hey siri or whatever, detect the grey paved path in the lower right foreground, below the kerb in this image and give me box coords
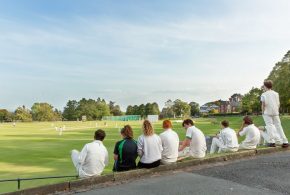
[75,152,290,195]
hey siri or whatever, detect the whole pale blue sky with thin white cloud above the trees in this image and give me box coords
[0,0,290,110]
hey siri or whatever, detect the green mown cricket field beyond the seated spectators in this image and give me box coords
[0,116,290,193]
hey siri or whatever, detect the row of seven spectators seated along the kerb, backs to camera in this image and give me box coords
[71,116,274,177]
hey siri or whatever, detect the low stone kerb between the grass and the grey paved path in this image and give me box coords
[5,148,290,195]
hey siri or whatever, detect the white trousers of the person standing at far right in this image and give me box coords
[263,115,288,143]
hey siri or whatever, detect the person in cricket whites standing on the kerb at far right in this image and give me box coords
[261,80,289,148]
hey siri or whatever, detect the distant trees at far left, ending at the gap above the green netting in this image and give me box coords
[0,98,123,122]
